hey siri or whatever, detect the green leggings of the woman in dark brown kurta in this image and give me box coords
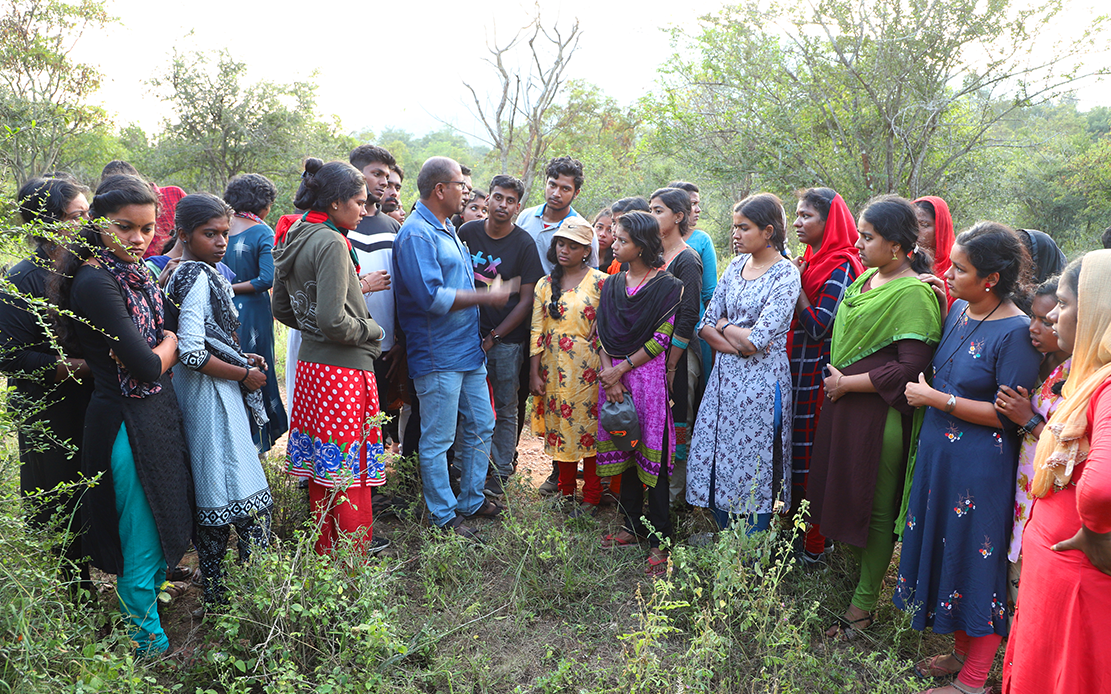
[850,408,905,612]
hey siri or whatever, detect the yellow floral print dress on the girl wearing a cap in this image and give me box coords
[529,269,608,463]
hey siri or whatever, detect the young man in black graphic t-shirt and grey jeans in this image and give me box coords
[459,175,544,494]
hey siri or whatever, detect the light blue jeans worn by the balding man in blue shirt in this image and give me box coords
[413,366,493,527]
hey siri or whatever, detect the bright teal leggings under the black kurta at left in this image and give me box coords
[112,424,170,655]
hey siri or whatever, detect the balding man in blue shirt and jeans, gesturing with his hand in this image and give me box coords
[393,157,509,539]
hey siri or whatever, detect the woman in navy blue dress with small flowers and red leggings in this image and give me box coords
[894,222,1041,694]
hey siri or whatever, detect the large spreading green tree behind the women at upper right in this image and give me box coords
[650,0,1107,204]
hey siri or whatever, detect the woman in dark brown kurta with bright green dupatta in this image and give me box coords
[808,195,941,638]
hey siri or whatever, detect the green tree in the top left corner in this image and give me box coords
[0,0,113,184]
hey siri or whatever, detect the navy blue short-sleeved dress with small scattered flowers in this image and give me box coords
[894,301,1041,636]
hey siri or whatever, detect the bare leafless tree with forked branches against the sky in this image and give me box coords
[463,4,582,197]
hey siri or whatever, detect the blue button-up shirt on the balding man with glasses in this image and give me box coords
[392,202,486,379]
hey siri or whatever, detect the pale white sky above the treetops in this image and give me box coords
[74,0,1111,143]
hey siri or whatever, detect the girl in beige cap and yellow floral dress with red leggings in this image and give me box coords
[529,217,608,517]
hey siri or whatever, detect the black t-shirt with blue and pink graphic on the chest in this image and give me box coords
[459,220,544,344]
